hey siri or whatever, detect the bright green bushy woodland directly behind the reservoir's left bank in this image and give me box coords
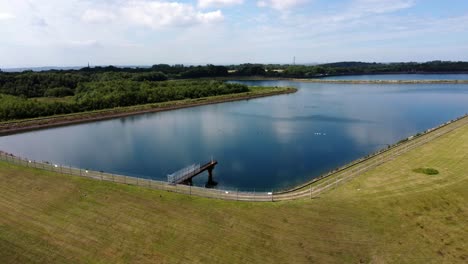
[0,80,249,121]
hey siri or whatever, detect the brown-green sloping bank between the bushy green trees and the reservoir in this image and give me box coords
[0,87,297,136]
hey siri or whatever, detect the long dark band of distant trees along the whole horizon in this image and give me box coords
[0,61,468,98]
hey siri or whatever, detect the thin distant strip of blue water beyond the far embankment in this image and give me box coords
[322,73,468,80]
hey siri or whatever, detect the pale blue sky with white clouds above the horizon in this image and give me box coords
[0,0,468,68]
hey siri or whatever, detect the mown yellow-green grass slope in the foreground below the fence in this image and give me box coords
[0,126,468,263]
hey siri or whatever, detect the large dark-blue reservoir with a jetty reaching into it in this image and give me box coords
[0,81,468,190]
